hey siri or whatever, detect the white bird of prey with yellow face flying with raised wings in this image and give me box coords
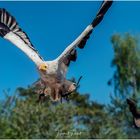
[0,1,112,101]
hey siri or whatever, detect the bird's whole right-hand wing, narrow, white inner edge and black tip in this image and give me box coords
[57,1,112,75]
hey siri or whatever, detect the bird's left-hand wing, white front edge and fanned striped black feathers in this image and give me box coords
[0,9,43,66]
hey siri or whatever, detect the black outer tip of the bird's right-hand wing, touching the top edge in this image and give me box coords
[91,0,113,27]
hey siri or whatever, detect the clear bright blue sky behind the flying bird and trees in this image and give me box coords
[0,1,140,103]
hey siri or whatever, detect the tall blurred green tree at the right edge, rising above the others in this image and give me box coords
[107,34,140,138]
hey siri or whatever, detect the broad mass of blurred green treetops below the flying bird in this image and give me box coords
[0,87,104,139]
